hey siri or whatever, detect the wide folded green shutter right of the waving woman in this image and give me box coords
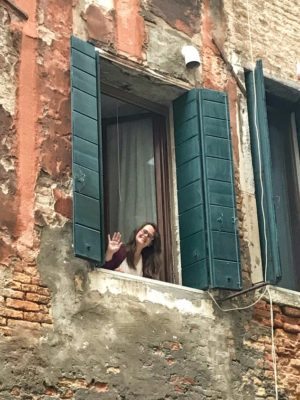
[174,89,241,290]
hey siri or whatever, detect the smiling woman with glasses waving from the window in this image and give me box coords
[103,222,161,279]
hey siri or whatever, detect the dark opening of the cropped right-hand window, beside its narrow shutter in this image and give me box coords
[267,96,300,291]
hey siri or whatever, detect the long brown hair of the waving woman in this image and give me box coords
[126,222,161,279]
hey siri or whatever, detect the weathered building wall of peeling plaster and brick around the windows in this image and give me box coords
[0,0,300,400]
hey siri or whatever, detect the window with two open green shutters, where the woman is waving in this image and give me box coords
[71,34,241,289]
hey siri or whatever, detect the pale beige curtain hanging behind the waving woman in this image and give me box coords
[107,118,156,242]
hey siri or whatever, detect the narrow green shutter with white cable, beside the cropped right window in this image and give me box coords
[245,60,281,284]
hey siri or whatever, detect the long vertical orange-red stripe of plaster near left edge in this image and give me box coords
[17,0,38,247]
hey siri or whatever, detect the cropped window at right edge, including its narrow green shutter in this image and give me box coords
[246,62,300,291]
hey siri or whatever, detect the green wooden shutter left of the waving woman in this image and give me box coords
[71,37,104,263]
